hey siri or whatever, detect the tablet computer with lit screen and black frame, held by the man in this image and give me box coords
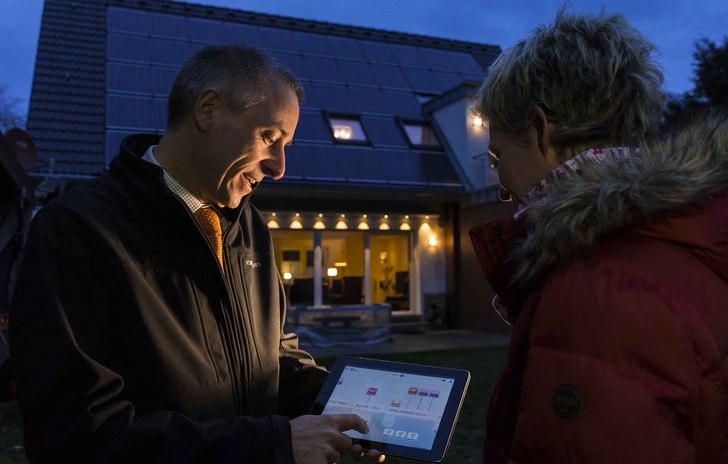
[311,356,470,462]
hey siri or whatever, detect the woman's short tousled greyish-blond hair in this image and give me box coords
[474,9,665,156]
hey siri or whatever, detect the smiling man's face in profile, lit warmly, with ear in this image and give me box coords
[196,79,299,208]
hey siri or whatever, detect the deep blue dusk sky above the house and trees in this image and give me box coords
[0,0,728,119]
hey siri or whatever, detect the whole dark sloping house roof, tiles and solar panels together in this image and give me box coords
[27,0,500,195]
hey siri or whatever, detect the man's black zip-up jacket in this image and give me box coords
[10,135,326,464]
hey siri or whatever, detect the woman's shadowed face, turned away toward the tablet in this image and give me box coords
[489,125,559,202]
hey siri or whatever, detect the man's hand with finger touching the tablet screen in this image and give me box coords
[291,414,384,464]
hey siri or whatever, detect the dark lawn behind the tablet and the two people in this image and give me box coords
[0,346,506,464]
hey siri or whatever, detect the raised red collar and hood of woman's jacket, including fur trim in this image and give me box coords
[470,121,728,320]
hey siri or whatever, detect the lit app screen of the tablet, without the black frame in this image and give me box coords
[323,366,453,449]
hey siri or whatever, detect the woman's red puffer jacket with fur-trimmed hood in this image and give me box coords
[471,120,728,464]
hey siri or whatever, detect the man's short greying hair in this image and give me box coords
[167,45,304,130]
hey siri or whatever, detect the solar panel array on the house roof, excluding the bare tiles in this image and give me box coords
[106,7,484,186]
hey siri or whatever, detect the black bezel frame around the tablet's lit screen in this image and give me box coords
[310,356,470,462]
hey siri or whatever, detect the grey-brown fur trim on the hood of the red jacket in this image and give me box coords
[508,117,728,288]
